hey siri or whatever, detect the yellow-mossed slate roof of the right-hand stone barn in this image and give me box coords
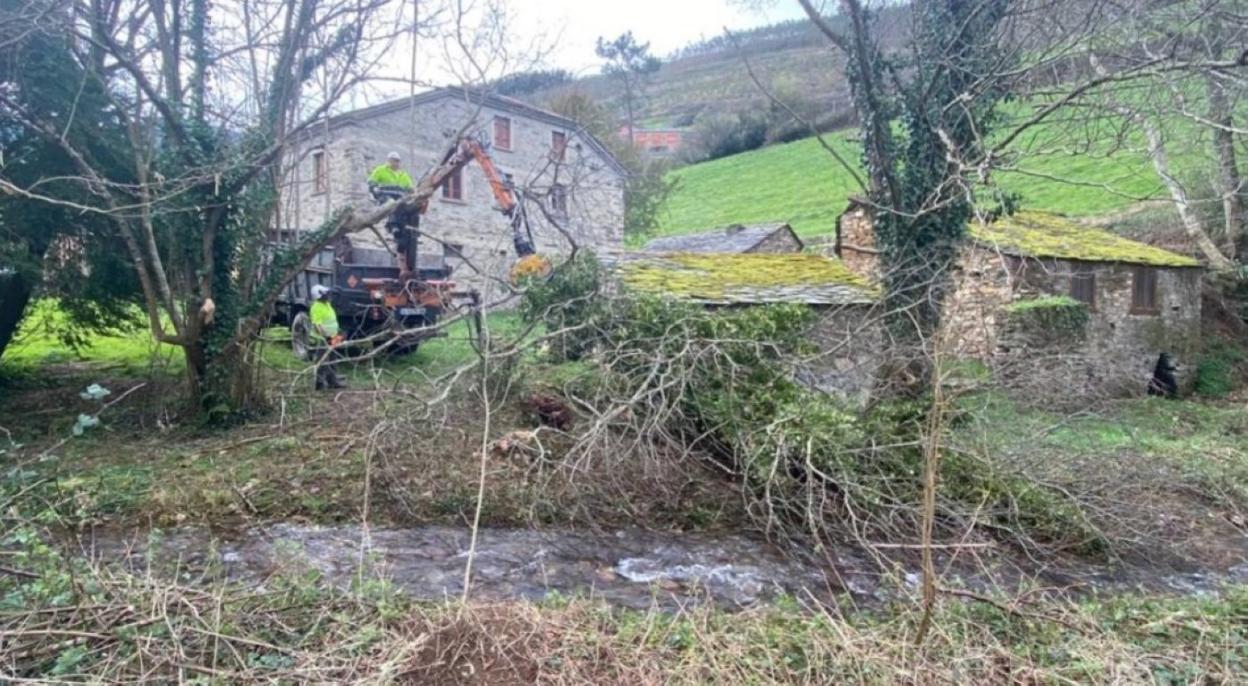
[970,212,1201,267]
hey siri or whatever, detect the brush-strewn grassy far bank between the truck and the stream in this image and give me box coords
[0,369,744,529]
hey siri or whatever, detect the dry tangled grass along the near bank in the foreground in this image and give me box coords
[0,545,1248,685]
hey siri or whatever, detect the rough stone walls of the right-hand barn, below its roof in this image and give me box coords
[836,207,1201,400]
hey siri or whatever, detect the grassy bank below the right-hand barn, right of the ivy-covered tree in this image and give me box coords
[951,393,1248,569]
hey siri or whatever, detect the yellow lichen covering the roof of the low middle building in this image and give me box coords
[622,253,876,301]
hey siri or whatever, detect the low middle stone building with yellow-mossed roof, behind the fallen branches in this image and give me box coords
[603,253,882,402]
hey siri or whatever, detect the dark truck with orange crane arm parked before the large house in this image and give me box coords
[265,137,549,359]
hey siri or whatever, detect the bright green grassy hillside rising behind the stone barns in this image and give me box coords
[656,131,1178,243]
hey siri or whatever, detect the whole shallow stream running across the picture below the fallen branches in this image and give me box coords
[81,523,1248,609]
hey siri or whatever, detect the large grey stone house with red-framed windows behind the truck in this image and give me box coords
[281,89,626,298]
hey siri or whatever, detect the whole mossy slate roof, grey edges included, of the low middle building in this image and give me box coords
[605,252,879,304]
